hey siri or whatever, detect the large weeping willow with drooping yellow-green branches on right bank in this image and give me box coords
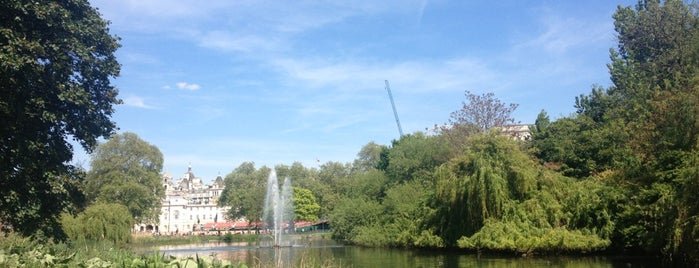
[431,132,537,246]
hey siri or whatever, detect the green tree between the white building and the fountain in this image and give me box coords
[218,162,272,229]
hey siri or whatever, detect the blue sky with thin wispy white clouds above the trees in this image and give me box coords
[74,0,636,182]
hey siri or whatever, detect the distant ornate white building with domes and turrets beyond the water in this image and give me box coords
[137,166,230,234]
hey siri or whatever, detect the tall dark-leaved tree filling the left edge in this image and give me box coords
[0,0,121,238]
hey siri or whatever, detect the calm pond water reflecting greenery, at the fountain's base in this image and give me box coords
[138,239,661,268]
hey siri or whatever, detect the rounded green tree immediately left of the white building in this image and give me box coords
[86,132,165,222]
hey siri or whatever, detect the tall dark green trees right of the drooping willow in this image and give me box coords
[533,0,699,263]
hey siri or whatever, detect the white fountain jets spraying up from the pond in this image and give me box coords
[262,170,294,247]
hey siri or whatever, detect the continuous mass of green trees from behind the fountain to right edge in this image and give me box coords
[220,1,699,264]
